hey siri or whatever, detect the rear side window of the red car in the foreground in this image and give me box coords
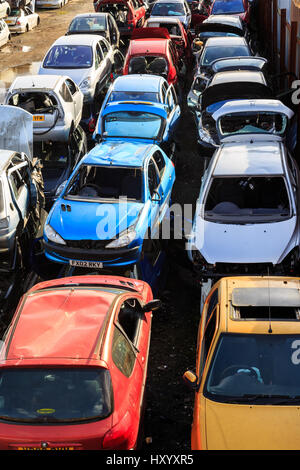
[112,328,135,377]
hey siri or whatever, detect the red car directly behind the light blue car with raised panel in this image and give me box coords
[123,28,182,86]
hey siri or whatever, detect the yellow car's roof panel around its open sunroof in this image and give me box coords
[219,276,300,334]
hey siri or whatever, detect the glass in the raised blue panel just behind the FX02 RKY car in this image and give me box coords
[104,111,163,139]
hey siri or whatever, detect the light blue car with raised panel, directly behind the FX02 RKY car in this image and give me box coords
[94,75,181,159]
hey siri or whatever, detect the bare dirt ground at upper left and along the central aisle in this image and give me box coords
[0,0,205,452]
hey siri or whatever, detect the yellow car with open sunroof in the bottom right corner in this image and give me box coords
[184,277,300,450]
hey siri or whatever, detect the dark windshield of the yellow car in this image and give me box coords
[204,334,300,405]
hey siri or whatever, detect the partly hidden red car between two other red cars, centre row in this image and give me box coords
[145,16,192,65]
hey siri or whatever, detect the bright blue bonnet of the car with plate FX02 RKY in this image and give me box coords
[48,199,144,240]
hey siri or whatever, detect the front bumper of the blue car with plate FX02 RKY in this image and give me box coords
[44,240,141,267]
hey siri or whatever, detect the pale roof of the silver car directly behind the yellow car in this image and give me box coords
[213,141,284,177]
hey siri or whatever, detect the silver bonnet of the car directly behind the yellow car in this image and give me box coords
[193,216,297,265]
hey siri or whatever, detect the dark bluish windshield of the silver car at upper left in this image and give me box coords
[43,46,93,69]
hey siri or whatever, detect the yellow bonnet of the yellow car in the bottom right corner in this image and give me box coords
[205,399,300,450]
